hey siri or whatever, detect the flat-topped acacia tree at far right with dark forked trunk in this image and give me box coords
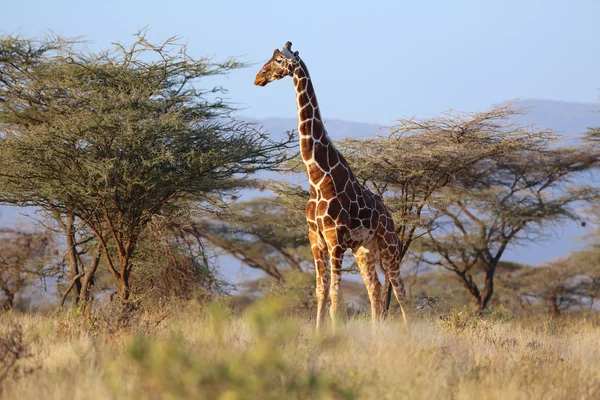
[425,145,598,310]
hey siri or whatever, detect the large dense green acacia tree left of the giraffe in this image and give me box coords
[0,32,287,300]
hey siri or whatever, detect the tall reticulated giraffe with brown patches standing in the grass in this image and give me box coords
[254,42,406,329]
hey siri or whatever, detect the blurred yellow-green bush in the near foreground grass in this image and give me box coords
[108,299,355,399]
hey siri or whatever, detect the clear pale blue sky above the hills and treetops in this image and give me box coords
[0,0,600,124]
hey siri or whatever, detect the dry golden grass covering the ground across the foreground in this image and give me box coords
[0,301,600,400]
